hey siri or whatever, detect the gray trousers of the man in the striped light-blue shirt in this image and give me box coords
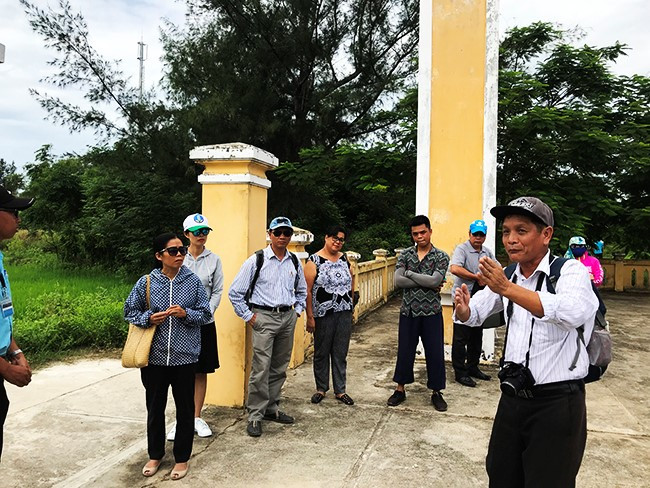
[246,307,298,421]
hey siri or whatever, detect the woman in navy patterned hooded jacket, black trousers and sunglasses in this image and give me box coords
[124,233,212,479]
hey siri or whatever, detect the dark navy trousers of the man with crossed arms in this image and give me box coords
[393,313,446,391]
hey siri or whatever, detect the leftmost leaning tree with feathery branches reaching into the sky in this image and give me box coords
[20,0,200,272]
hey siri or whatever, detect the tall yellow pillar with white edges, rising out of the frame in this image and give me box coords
[416,0,499,358]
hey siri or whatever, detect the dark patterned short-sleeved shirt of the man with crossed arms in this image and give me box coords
[397,246,449,317]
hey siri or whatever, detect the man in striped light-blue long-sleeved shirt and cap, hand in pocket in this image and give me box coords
[228,217,307,437]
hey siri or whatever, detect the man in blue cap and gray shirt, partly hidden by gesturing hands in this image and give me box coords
[449,220,495,387]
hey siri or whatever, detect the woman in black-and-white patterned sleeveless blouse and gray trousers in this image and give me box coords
[305,226,354,405]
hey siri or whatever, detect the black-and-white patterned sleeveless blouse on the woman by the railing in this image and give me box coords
[308,254,353,318]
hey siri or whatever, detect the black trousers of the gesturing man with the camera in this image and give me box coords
[485,384,587,488]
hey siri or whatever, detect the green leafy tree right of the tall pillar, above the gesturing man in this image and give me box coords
[497,23,650,253]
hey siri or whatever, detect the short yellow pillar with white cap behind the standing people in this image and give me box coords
[190,143,278,407]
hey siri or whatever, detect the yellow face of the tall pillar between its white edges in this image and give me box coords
[429,0,486,255]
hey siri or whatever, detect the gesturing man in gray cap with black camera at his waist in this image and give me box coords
[454,197,598,488]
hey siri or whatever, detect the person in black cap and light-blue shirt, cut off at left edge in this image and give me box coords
[0,186,34,457]
